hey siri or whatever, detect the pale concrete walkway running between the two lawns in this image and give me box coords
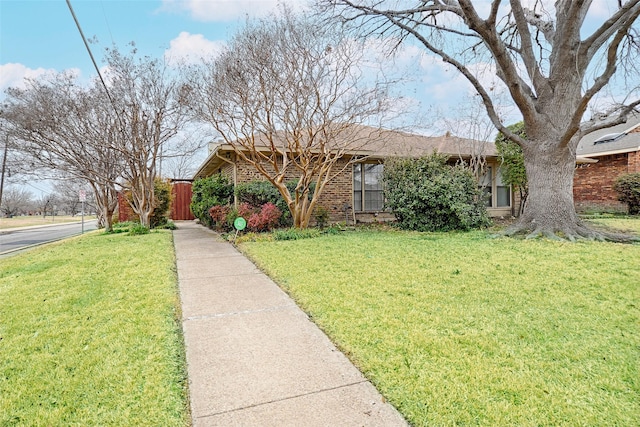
[174,222,407,427]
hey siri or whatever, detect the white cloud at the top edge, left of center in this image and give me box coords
[160,0,307,22]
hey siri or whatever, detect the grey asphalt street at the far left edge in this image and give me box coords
[0,220,97,255]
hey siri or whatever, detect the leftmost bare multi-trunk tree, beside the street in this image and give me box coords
[5,73,123,231]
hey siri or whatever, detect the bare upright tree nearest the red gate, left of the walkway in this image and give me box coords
[105,48,190,227]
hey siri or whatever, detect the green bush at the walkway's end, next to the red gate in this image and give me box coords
[191,174,233,227]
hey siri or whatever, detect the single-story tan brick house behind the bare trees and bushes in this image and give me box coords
[194,127,515,223]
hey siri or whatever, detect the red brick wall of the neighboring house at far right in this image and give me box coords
[573,152,638,211]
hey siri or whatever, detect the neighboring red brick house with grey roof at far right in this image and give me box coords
[573,115,640,212]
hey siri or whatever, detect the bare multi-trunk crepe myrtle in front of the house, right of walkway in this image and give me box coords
[193,7,392,228]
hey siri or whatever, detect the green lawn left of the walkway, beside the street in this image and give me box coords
[0,232,189,426]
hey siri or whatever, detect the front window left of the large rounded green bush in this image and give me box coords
[353,163,384,212]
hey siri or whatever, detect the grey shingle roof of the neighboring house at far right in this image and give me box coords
[576,114,640,157]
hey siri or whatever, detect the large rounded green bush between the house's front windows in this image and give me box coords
[383,153,489,231]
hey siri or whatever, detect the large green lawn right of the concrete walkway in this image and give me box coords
[241,227,640,426]
